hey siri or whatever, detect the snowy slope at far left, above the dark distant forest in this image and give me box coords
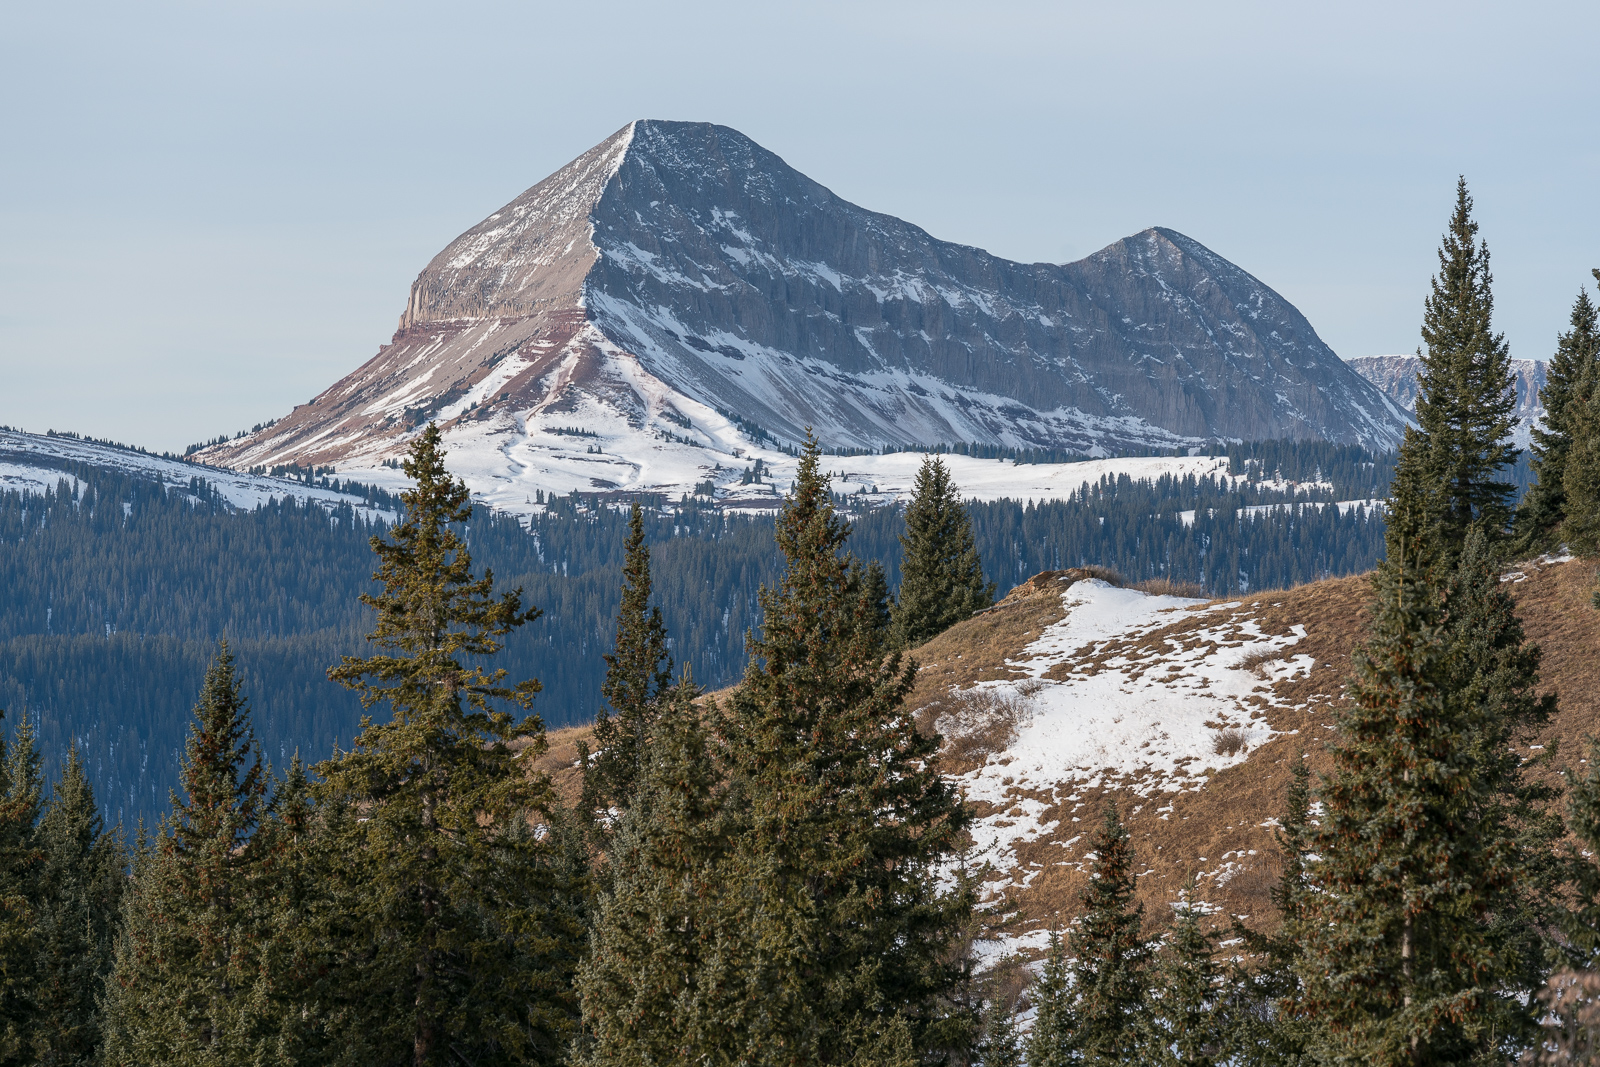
[0,430,390,518]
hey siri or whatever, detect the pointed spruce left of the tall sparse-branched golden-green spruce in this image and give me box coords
[104,645,277,1065]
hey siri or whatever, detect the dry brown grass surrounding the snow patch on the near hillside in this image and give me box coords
[534,563,1600,953]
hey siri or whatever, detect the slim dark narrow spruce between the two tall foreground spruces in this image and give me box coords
[579,501,672,814]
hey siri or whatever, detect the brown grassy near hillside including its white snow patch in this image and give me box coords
[541,560,1600,950]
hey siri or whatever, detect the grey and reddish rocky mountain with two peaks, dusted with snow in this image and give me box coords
[206,122,1405,466]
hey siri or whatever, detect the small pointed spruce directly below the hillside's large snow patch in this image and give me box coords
[1027,805,1150,1065]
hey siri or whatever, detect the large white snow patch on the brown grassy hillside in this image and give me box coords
[958,579,1314,953]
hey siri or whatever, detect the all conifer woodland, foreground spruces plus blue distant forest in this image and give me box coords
[0,181,1600,1067]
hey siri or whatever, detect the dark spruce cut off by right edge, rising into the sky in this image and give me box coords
[1517,290,1600,552]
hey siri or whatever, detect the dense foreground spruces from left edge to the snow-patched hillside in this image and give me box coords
[0,426,973,1067]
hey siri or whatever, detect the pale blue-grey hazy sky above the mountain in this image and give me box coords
[0,0,1600,451]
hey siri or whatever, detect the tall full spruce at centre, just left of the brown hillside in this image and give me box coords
[714,435,973,1064]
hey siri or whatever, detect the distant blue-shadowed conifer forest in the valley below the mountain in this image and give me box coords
[0,442,1465,827]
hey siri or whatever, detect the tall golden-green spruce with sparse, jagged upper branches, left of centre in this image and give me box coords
[317,424,578,1067]
